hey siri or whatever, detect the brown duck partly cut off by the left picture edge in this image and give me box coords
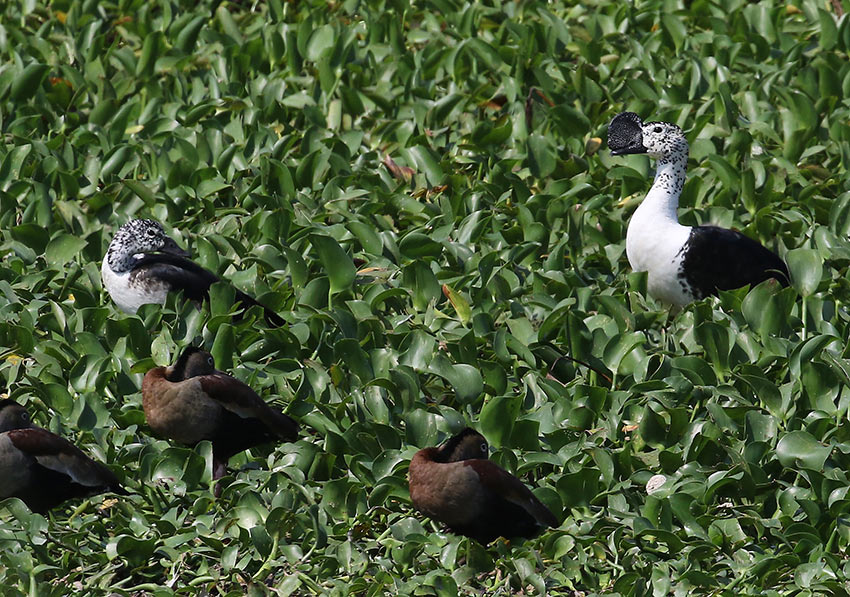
[0,400,127,513]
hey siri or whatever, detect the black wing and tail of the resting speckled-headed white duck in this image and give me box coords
[131,253,286,327]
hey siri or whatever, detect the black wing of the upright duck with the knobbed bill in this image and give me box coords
[679,226,791,298]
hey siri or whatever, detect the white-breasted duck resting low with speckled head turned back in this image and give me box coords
[100,220,285,326]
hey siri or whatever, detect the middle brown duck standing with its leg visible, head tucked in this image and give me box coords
[142,346,298,486]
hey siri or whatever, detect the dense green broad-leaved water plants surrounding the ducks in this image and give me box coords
[0,0,850,597]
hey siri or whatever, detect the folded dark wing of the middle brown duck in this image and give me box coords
[198,372,298,441]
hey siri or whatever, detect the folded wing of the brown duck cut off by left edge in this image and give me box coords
[7,427,126,493]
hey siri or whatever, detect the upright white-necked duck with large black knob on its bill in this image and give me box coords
[608,112,790,307]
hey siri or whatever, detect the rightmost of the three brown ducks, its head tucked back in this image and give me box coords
[409,427,559,545]
